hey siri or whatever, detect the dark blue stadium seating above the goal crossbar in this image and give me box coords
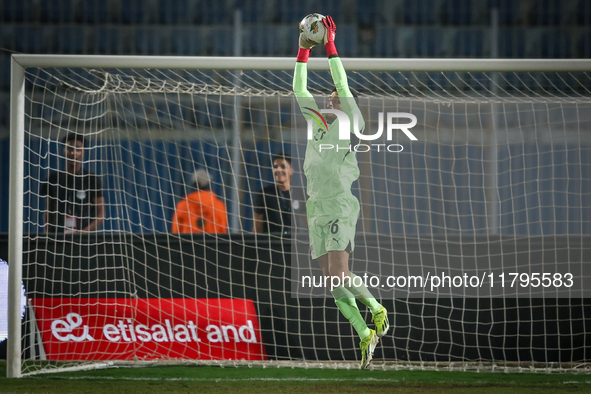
[0,0,591,58]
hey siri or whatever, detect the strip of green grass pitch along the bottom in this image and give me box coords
[0,361,591,394]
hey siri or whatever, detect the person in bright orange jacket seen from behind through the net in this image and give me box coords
[172,170,228,233]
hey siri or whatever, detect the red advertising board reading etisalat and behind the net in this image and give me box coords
[31,298,267,360]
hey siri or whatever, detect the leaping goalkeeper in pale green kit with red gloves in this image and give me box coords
[293,16,390,368]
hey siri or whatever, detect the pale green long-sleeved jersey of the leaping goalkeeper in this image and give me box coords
[293,57,365,200]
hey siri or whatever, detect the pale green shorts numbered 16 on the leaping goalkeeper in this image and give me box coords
[306,194,359,259]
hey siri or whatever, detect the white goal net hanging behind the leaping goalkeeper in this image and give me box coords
[9,55,591,376]
